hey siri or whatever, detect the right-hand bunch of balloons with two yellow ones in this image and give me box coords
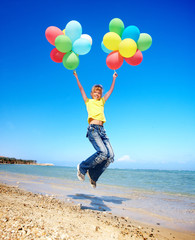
[101,18,152,70]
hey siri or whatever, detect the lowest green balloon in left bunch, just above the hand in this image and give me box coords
[63,52,79,70]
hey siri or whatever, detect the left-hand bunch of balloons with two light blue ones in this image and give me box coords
[45,21,92,70]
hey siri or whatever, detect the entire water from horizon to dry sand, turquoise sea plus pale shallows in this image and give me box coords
[0,164,195,232]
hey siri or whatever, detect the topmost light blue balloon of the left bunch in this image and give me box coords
[65,20,82,42]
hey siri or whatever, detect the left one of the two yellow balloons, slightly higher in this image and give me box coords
[103,32,121,51]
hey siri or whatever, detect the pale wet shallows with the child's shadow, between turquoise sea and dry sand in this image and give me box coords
[0,171,195,233]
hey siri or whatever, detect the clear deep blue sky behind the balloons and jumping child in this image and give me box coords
[0,0,195,170]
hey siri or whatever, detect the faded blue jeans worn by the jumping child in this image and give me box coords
[80,124,114,182]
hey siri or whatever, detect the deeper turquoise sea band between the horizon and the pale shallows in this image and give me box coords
[0,164,195,197]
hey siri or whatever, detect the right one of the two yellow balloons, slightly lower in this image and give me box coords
[119,38,137,58]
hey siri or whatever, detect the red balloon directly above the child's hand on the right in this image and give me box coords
[106,51,123,70]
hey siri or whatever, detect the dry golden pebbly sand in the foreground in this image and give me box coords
[0,184,195,240]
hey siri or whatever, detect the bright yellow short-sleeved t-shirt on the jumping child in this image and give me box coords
[85,97,106,123]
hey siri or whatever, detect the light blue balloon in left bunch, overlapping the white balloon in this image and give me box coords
[72,38,91,55]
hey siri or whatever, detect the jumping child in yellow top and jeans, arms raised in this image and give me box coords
[73,71,118,188]
